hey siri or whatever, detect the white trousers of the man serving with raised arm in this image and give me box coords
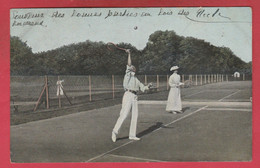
[113,92,138,137]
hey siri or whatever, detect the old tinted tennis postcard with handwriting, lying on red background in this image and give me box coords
[10,7,253,163]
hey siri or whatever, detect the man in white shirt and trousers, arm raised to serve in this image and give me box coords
[112,49,152,142]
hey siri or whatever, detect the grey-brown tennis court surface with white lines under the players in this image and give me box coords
[11,81,252,163]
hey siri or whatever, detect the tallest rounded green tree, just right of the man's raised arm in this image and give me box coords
[140,30,183,74]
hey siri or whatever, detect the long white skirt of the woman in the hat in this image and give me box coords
[166,88,182,111]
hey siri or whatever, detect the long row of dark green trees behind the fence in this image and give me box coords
[11,31,252,75]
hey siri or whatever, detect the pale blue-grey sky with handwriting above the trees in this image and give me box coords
[10,7,252,62]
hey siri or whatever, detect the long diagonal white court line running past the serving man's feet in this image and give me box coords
[86,106,208,162]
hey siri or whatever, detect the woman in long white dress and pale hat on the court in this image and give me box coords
[166,66,184,114]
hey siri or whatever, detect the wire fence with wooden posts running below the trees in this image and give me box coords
[10,74,252,113]
